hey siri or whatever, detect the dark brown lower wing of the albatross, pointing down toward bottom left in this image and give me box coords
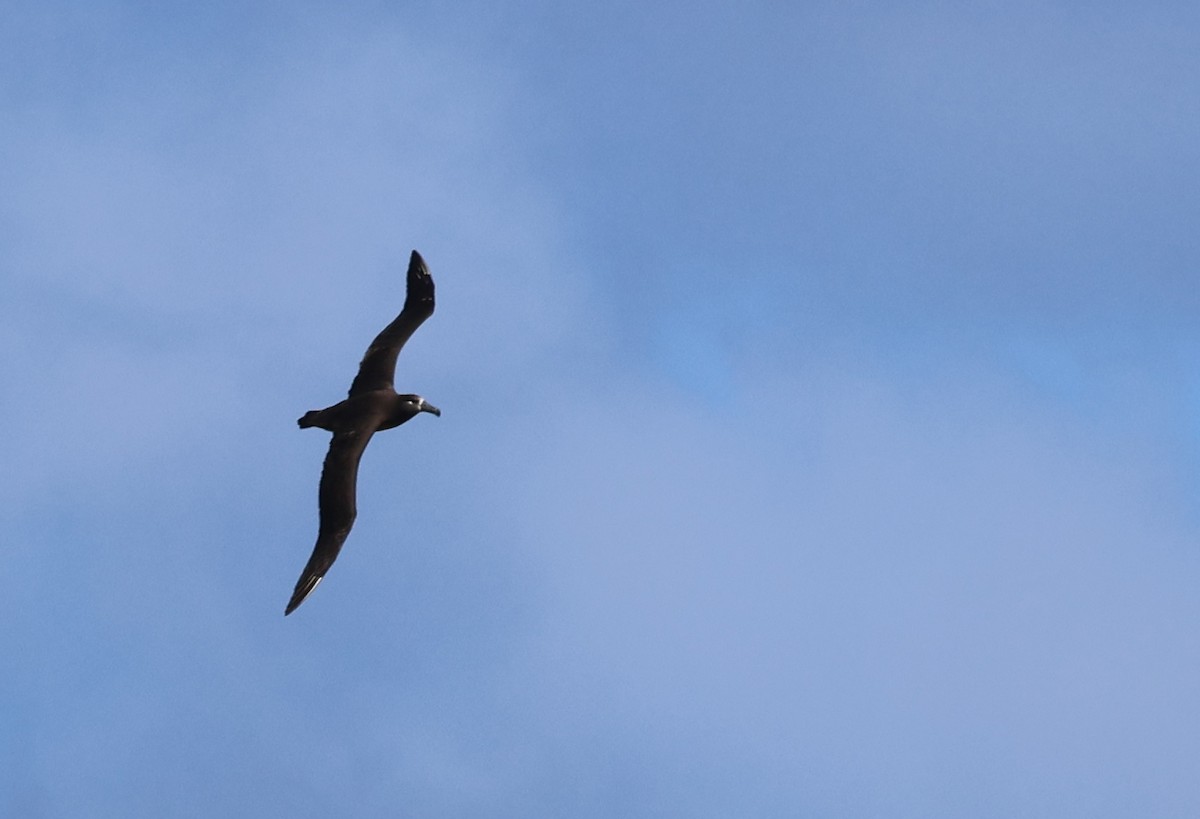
[283,429,374,615]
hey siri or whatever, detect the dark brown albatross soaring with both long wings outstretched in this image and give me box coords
[283,250,442,616]
